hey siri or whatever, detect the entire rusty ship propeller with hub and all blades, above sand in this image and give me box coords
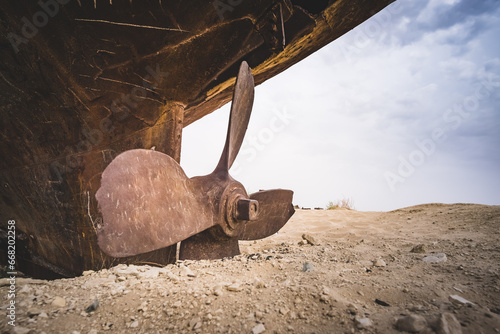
[96,62,294,260]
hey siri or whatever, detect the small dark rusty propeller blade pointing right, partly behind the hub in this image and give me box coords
[238,189,295,240]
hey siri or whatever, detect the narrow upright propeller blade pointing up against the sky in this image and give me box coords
[217,61,254,171]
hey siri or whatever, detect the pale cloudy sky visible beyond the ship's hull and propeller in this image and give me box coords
[181,0,500,211]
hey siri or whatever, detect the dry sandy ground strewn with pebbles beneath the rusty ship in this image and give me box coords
[0,204,500,334]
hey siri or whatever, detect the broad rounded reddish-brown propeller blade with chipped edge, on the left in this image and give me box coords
[96,149,214,257]
